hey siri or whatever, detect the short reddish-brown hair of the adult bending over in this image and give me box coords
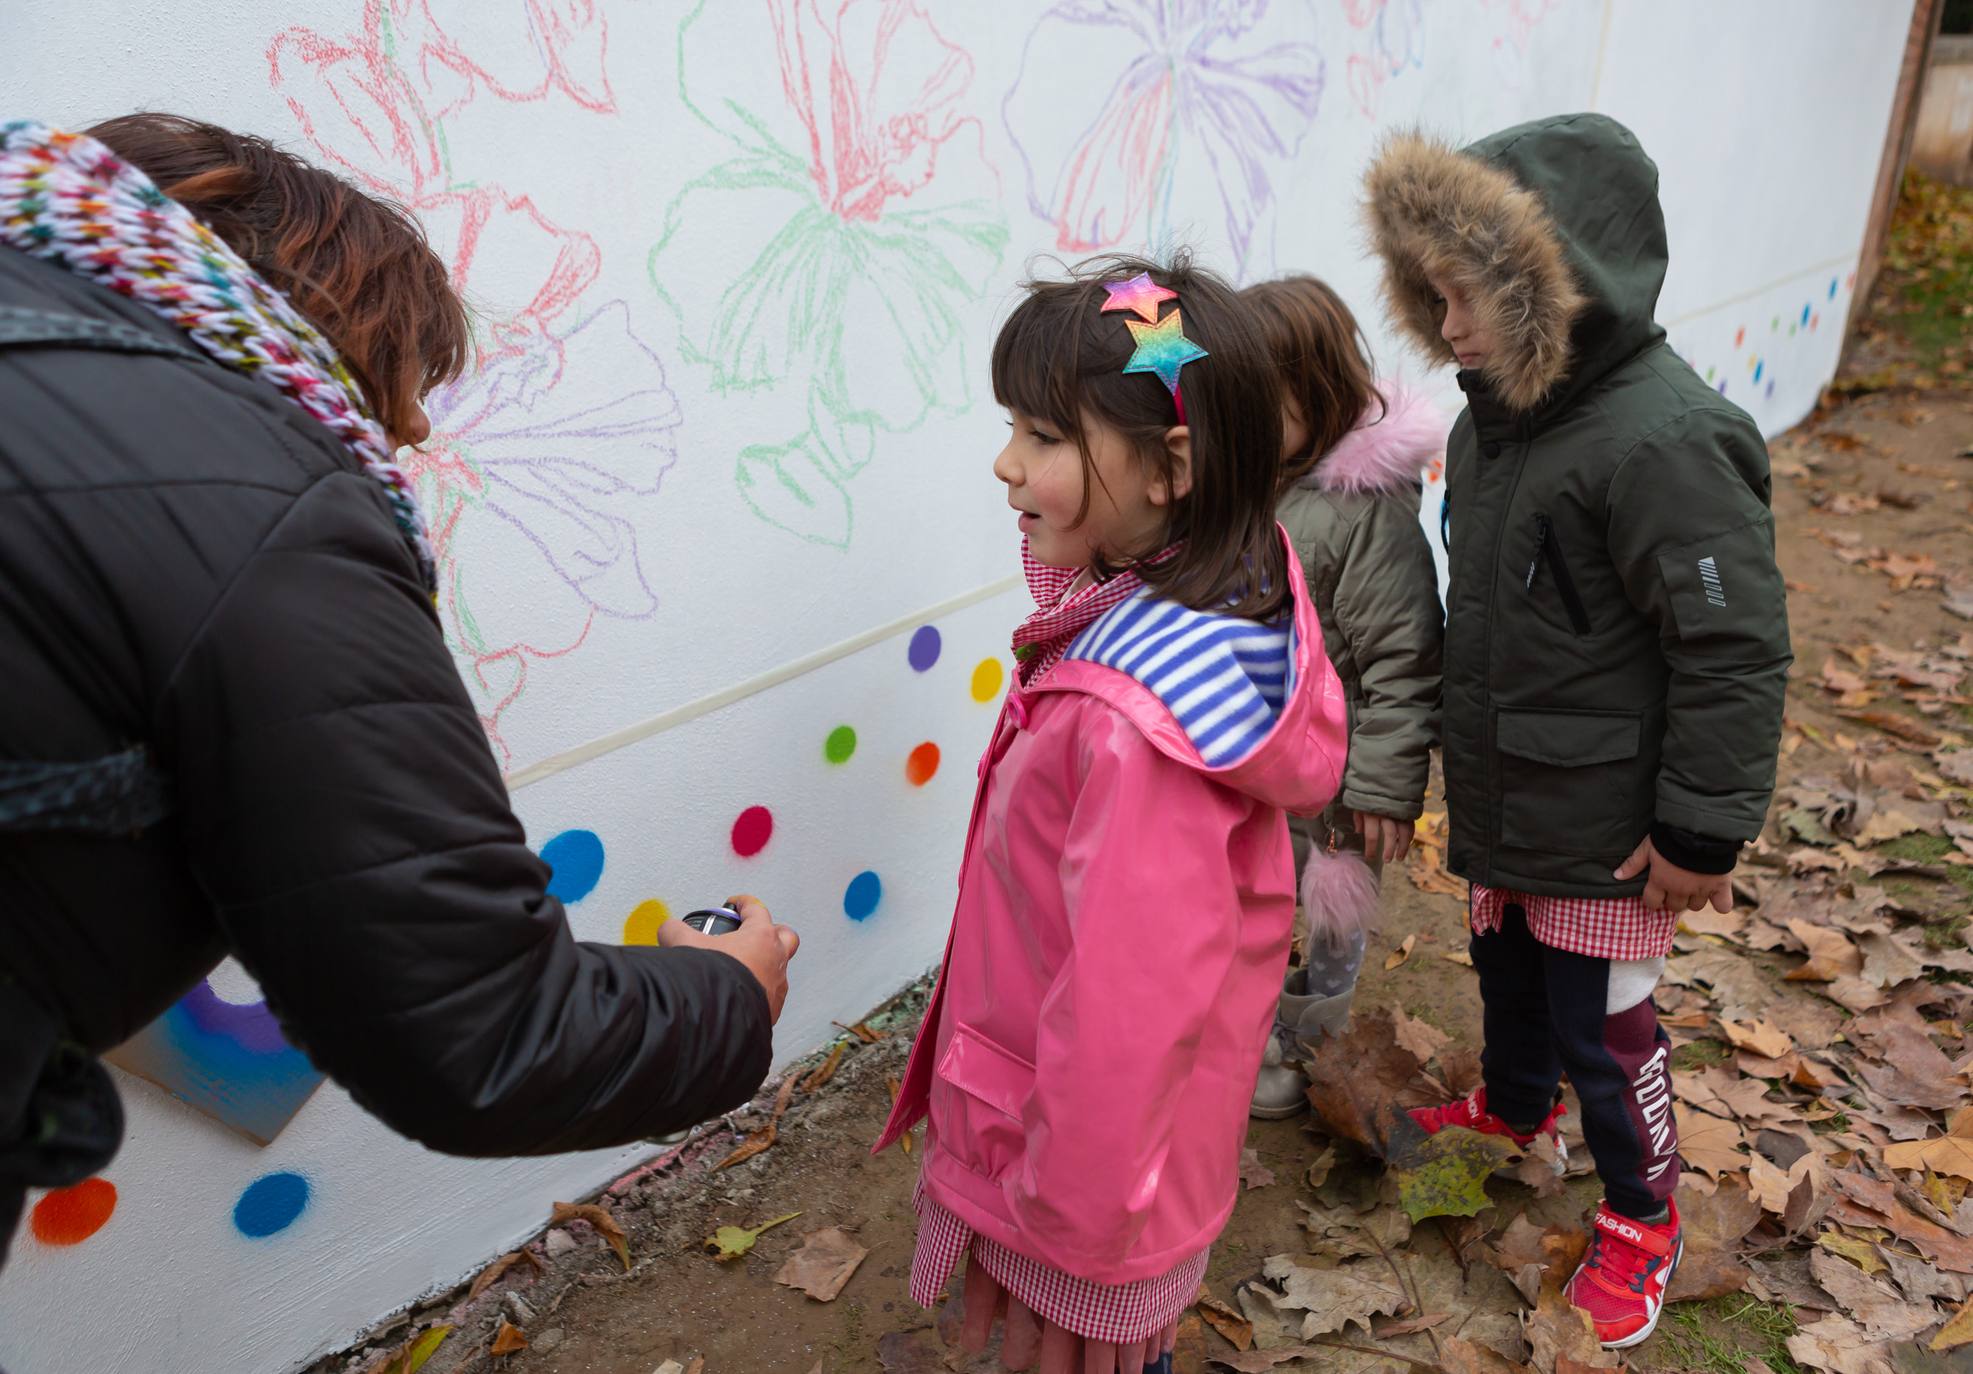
[87,115,472,434]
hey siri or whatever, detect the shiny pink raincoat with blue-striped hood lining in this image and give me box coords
[878,533,1348,1283]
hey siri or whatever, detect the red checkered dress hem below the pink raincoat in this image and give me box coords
[912,1194,1211,1344]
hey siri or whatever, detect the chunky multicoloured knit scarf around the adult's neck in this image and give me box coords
[0,120,438,592]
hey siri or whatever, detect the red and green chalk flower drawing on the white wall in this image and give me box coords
[651,0,1008,549]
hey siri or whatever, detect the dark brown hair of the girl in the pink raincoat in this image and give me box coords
[992,253,1290,620]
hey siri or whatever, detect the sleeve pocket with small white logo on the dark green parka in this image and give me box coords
[1657,517,1788,655]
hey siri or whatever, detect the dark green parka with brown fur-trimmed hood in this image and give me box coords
[1367,115,1790,896]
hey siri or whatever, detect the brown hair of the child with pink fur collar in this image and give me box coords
[1241,276,1383,488]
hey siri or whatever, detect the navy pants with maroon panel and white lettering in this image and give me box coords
[1470,906,1679,1220]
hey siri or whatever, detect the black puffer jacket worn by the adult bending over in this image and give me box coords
[0,249,771,1184]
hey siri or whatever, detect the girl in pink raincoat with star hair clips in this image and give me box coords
[878,257,1346,1374]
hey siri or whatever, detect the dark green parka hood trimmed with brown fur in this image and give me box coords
[1363,115,1667,411]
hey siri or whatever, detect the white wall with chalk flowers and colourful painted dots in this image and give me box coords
[0,0,1910,1374]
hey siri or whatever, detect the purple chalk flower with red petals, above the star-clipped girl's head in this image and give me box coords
[1002,0,1324,270]
